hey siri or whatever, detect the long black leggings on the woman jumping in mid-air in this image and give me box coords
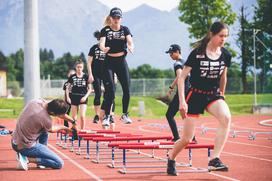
[101,56,130,115]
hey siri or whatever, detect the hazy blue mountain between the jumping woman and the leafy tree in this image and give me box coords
[123,5,189,69]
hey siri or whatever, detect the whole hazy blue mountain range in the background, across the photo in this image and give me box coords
[0,0,256,69]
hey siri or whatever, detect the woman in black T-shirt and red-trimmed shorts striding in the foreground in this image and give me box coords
[167,22,231,175]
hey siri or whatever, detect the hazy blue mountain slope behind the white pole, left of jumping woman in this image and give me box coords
[0,0,109,57]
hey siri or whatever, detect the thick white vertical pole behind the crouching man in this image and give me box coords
[24,0,40,104]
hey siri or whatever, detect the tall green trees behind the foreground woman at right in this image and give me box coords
[179,0,272,93]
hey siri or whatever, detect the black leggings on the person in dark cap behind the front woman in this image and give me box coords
[166,92,179,140]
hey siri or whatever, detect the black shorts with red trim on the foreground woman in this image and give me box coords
[186,88,224,116]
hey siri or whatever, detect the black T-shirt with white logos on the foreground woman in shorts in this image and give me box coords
[185,48,231,90]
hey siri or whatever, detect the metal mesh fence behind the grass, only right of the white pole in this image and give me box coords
[41,78,272,97]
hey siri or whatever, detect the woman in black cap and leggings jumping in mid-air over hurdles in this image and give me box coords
[99,8,134,126]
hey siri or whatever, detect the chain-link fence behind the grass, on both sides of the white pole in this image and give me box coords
[8,76,272,97]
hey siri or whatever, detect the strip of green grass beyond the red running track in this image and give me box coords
[0,94,272,118]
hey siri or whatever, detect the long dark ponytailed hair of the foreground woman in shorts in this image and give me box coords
[193,21,228,54]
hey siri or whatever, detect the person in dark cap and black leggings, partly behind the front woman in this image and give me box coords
[165,44,196,142]
